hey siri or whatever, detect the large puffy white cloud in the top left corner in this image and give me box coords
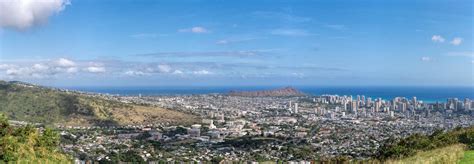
[0,0,70,30]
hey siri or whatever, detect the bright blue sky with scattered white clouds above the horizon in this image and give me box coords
[0,0,474,86]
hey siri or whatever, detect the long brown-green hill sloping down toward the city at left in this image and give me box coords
[0,81,196,125]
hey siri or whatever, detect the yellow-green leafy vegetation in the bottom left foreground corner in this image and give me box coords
[0,114,71,163]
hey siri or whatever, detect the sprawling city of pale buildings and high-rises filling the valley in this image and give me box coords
[63,94,474,161]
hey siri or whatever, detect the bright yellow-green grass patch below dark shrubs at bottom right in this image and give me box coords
[386,144,465,164]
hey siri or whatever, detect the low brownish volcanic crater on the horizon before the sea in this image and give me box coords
[229,87,304,97]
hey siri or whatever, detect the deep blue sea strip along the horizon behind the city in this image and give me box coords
[66,86,474,102]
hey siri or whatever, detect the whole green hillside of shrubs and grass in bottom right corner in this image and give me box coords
[377,126,474,164]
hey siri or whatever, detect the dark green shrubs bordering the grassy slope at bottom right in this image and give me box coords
[377,126,474,160]
